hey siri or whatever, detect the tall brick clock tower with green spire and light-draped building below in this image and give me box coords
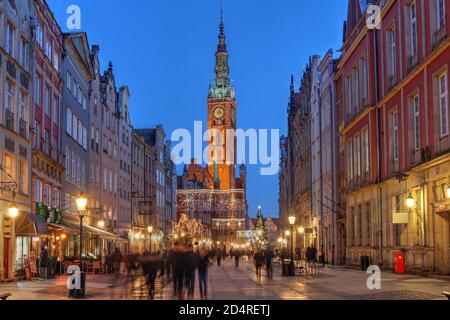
[177,13,247,248]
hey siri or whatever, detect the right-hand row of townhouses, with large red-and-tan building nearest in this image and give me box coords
[280,0,450,274]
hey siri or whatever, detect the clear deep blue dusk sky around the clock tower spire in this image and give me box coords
[47,0,347,217]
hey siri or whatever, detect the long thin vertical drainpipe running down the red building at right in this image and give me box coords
[373,29,383,267]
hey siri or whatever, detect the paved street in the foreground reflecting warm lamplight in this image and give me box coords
[0,259,450,300]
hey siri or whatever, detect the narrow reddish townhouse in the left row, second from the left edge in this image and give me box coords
[32,0,64,222]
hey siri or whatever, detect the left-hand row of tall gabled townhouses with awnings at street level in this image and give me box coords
[0,0,176,280]
